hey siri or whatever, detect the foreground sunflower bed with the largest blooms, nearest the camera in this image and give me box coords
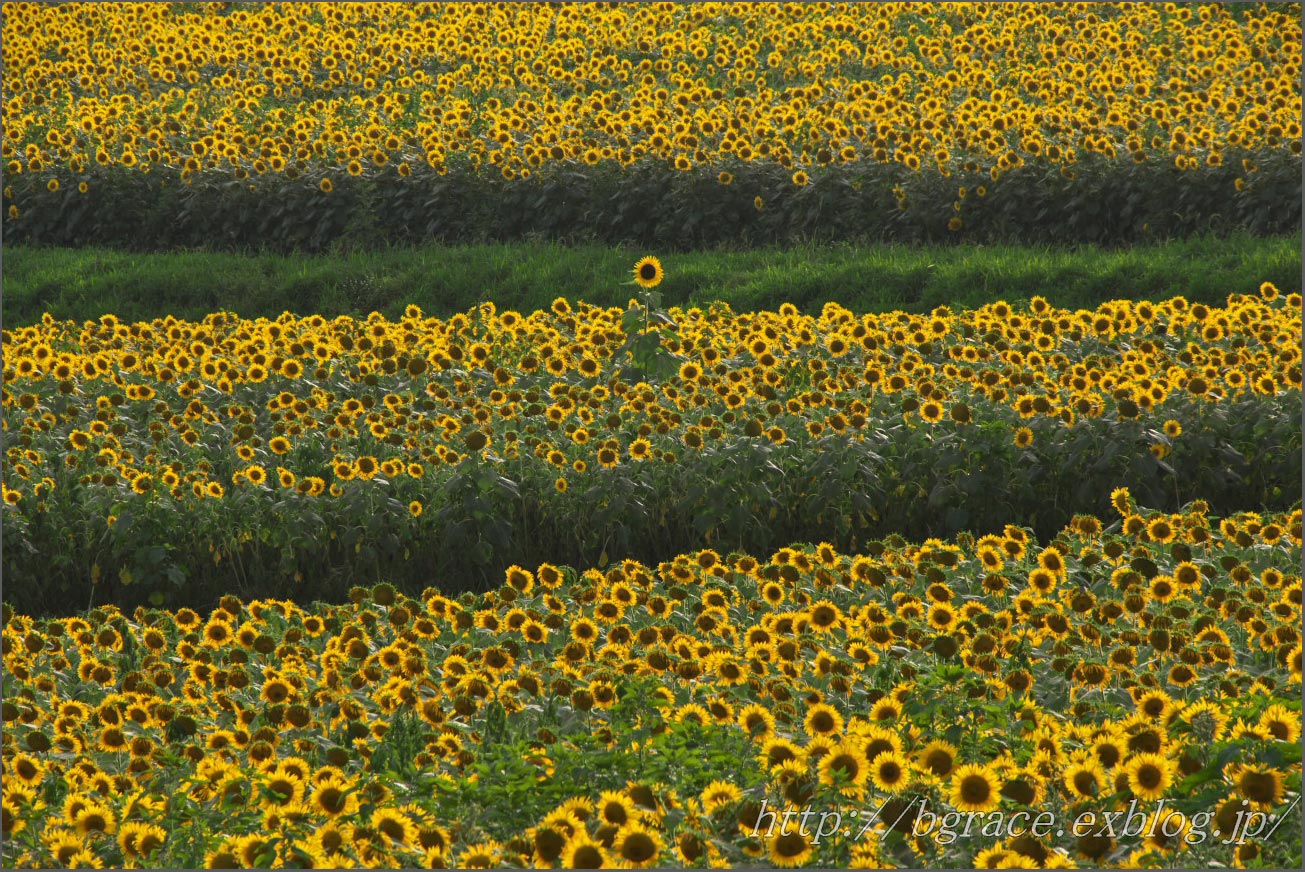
[0,501,1301,868]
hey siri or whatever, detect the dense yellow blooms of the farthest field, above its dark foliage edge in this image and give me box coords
[3,3,1301,185]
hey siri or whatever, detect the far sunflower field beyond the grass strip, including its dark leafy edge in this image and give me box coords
[0,3,1301,251]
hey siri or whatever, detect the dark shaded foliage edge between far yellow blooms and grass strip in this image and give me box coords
[4,149,1301,252]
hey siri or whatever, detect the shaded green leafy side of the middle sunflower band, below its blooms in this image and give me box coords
[4,392,1301,615]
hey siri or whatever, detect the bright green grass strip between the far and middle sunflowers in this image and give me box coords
[4,234,1301,326]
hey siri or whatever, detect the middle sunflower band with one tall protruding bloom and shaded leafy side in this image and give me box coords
[3,280,1301,611]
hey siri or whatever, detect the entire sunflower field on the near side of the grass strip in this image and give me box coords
[3,278,1301,868]
